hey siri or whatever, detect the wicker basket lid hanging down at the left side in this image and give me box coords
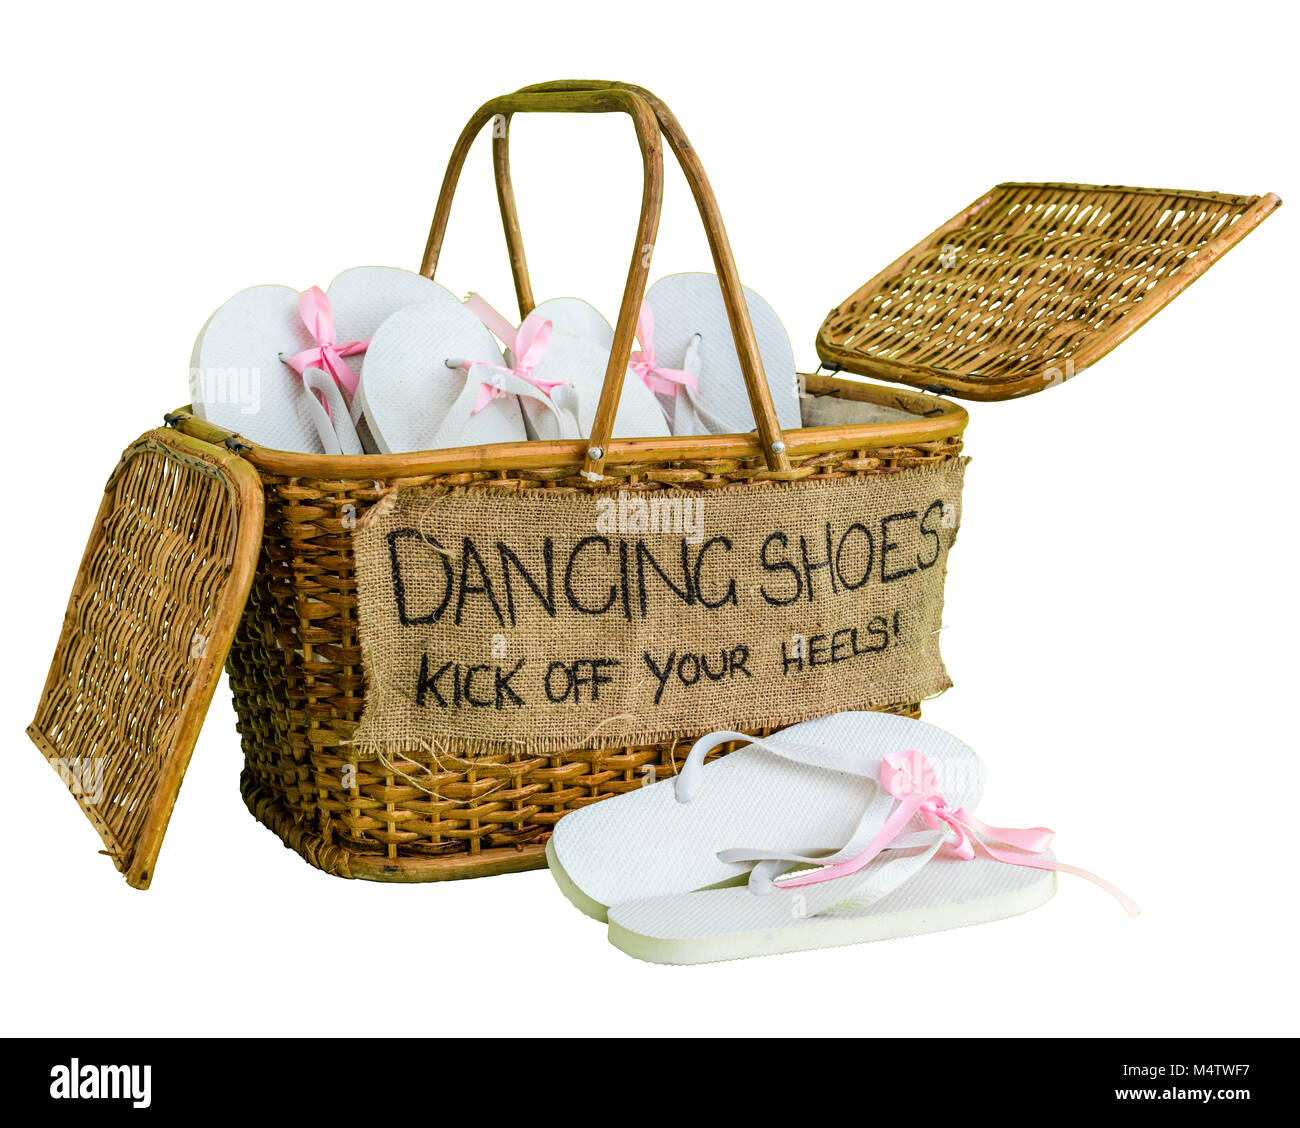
[27,429,263,889]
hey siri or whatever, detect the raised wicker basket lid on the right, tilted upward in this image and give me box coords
[816,183,1282,399]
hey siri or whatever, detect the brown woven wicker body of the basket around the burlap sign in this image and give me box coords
[215,420,963,881]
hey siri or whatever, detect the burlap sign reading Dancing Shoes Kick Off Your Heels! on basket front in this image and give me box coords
[352,459,966,759]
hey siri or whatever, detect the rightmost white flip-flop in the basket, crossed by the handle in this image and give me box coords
[638,274,801,435]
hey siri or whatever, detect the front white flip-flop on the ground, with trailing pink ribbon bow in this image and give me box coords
[598,734,1139,964]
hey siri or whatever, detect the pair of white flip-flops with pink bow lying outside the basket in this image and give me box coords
[546,712,1138,964]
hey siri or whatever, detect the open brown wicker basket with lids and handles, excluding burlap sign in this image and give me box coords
[29,82,1279,888]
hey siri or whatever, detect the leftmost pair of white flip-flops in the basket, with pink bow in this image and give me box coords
[190,266,454,454]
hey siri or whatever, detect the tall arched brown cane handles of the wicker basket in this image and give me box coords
[420,81,790,477]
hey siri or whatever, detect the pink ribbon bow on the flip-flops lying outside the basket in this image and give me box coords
[777,751,1141,916]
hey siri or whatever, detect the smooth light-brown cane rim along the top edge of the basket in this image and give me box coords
[175,374,970,481]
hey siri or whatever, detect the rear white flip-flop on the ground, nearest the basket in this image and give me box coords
[546,712,984,920]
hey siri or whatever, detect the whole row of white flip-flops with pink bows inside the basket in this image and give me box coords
[190,266,800,455]
